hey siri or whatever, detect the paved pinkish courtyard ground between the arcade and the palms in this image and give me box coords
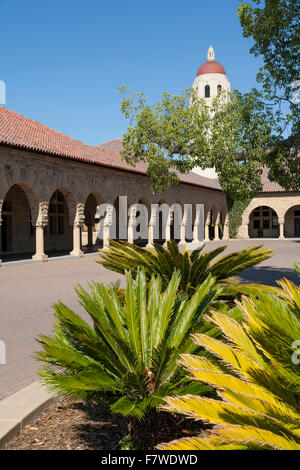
[0,240,300,399]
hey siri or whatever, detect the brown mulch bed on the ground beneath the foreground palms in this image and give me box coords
[1,399,211,450]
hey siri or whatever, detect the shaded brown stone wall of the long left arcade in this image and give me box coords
[0,146,227,253]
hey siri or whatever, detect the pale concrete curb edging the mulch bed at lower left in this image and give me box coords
[0,382,55,449]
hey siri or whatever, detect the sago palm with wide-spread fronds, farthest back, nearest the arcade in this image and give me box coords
[97,240,273,292]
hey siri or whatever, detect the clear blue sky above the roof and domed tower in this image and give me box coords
[0,0,261,145]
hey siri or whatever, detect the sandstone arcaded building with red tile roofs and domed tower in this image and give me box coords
[0,48,300,268]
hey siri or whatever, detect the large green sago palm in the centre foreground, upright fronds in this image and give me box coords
[36,270,221,419]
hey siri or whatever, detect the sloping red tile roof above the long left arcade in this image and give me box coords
[0,106,221,191]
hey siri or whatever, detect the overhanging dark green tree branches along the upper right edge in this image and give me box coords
[238,0,300,190]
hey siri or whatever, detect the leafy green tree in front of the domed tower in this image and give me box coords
[121,87,282,199]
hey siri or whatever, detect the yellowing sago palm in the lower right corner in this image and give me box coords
[160,280,300,450]
